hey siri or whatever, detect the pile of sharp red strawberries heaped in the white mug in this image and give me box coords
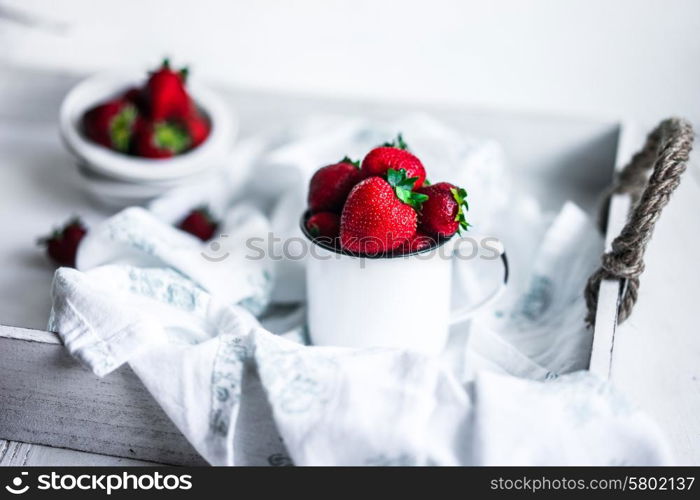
[305,134,469,255]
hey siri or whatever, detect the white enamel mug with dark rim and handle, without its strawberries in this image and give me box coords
[301,214,508,355]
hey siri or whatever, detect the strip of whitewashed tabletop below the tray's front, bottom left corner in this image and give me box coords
[0,440,158,467]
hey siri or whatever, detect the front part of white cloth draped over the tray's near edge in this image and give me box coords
[51,265,669,465]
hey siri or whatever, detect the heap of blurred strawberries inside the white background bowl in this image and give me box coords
[82,59,211,158]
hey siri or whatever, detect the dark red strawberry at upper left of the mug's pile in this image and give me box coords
[308,156,362,213]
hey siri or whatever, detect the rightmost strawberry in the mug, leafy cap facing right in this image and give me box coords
[418,182,469,237]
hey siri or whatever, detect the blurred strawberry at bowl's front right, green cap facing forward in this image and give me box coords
[132,120,191,158]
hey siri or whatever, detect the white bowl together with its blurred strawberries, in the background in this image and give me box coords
[60,60,236,202]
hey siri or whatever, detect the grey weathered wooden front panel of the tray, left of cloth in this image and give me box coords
[0,337,205,465]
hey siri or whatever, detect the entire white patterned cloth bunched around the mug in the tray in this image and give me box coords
[49,116,670,465]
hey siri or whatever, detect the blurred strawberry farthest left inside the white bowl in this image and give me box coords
[83,99,137,152]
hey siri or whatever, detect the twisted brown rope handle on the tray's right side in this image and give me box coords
[584,118,694,326]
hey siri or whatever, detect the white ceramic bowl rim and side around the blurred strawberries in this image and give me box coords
[59,73,238,184]
